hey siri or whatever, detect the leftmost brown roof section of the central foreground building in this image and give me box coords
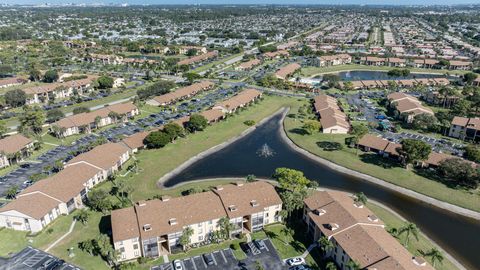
[110,207,140,242]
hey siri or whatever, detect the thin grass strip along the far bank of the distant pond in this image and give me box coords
[301,64,468,77]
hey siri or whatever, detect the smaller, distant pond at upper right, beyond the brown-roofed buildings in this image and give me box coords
[315,70,455,81]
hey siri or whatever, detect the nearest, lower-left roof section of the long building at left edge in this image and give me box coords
[0,193,60,220]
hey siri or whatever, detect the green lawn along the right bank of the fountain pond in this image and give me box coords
[284,102,480,211]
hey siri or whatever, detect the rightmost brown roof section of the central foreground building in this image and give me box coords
[213,181,282,218]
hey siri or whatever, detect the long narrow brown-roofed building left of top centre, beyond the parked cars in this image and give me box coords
[146,81,215,106]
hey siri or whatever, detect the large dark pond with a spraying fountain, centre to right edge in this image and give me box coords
[164,112,480,269]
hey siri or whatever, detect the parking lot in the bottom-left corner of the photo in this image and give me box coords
[0,247,80,270]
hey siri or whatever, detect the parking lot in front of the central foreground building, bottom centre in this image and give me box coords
[151,239,288,270]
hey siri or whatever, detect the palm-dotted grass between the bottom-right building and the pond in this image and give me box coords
[367,203,458,270]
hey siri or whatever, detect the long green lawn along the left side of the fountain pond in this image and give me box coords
[129,96,298,201]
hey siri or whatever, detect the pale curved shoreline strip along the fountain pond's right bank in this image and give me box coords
[280,108,480,221]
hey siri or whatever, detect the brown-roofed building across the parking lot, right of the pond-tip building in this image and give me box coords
[387,92,434,123]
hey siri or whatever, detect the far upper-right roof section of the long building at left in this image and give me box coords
[66,143,129,170]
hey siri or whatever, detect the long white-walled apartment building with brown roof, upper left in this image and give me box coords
[22,76,96,105]
